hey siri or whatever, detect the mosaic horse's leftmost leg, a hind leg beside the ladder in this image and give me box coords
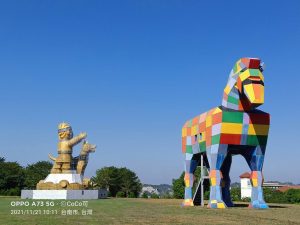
[182,153,198,206]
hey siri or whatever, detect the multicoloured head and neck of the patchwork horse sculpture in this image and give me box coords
[222,58,264,111]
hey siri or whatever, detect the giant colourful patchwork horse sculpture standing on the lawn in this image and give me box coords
[182,58,270,208]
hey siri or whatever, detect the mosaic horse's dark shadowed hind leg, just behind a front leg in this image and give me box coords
[221,154,234,207]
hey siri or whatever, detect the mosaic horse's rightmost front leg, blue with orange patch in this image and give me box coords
[244,146,268,209]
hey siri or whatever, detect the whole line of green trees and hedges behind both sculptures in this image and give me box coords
[0,157,300,203]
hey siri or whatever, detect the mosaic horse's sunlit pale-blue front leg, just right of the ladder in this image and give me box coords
[207,145,228,208]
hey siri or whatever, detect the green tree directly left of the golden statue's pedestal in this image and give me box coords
[24,161,52,189]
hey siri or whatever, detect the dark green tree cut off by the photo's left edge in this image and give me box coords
[0,160,24,195]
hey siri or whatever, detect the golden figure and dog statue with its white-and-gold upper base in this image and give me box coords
[37,122,96,190]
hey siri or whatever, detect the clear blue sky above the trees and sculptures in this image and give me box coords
[0,0,300,184]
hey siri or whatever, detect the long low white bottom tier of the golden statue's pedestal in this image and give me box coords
[21,189,107,199]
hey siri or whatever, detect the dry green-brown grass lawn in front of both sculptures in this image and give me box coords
[0,197,300,225]
